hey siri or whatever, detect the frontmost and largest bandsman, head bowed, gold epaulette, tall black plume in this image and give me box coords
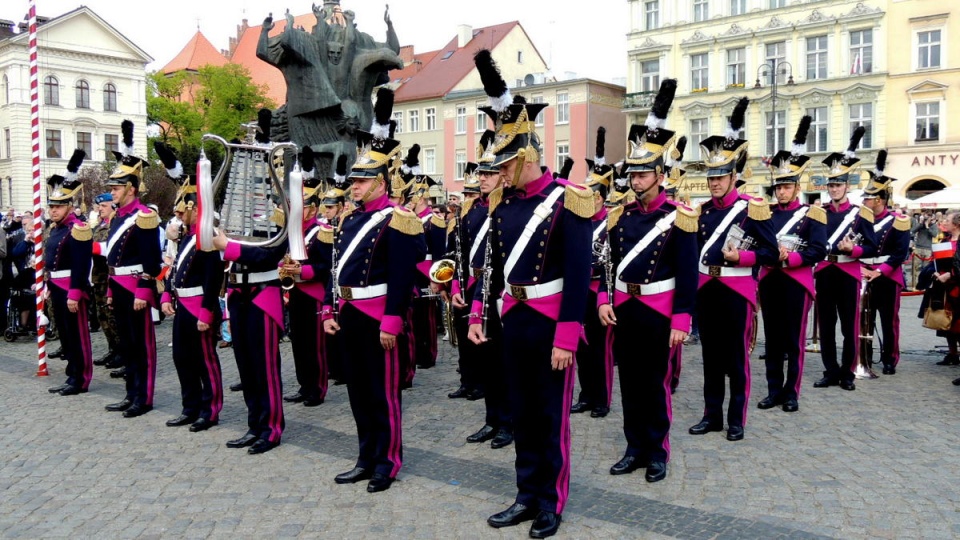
[469,49,595,538]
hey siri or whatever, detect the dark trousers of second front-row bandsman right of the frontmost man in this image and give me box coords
[697,279,755,427]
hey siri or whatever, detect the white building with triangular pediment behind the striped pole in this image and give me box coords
[0,7,153,210]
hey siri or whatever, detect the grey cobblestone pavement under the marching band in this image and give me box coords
[0,298,960,539]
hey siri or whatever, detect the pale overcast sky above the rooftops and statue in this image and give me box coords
[0,0,628,81]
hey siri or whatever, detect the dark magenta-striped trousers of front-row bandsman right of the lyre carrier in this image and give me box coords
[340,302,407,478]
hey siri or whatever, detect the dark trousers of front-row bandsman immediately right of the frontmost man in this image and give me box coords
[613,298,682,462]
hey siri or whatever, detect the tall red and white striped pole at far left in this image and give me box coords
[25,0,49,377]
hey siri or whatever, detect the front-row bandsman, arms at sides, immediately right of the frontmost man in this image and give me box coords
[597,79,697,482]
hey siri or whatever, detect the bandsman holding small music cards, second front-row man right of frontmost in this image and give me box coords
[689,98,777,441]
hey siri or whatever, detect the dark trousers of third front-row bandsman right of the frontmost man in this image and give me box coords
[760,270,813,402]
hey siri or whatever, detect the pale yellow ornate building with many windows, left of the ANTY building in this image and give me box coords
[624,0,888,202]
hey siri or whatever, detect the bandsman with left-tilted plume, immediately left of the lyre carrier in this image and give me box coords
[154,141,223,432]
